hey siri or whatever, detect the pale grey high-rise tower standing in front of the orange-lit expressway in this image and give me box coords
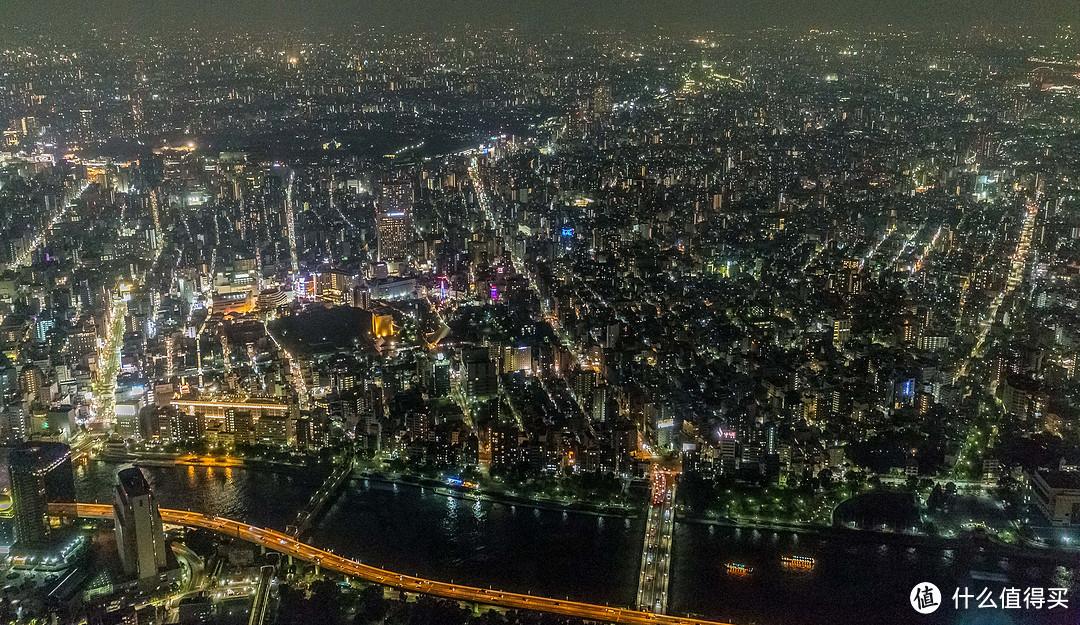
[112,466,165,580]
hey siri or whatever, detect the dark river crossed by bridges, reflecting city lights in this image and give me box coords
[76,461,1080,625]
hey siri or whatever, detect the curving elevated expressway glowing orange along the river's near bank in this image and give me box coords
[49,503,725,625]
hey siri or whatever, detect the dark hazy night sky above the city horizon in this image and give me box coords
[0,0,1080,31]
